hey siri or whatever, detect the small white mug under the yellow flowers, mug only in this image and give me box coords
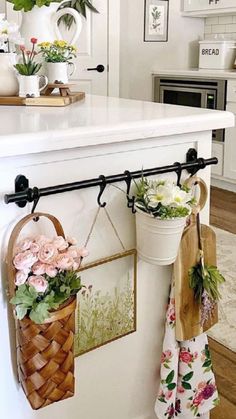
[46,63,75,83]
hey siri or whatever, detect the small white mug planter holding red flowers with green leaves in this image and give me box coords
[14,38,48,97]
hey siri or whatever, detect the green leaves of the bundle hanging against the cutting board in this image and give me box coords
[189,262,225,303]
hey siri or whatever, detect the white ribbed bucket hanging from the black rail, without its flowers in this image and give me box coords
[135,208,187,265]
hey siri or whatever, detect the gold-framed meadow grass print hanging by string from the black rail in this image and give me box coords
[74,249,137,356]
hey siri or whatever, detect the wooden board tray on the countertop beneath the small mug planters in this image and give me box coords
[0,92,85,106]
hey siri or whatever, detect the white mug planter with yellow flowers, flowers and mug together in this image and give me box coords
[39,40,76,83]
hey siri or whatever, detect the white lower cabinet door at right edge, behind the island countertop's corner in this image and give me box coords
[224,103,236,180]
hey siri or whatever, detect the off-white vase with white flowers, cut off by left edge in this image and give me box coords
[0,13,18,96]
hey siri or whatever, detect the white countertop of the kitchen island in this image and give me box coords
[0,95,234,157]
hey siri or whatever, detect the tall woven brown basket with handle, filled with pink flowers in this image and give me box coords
[7,213,87,409]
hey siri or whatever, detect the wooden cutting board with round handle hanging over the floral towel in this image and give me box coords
[173,178,218,341]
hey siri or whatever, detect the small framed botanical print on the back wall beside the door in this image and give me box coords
[144,0,169,42]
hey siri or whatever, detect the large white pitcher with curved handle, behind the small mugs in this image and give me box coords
[20,0,82,49]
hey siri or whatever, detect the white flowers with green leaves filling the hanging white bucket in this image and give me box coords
[135,177,195,219]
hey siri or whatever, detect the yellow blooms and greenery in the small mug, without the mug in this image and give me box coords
[38,40,76,63]
